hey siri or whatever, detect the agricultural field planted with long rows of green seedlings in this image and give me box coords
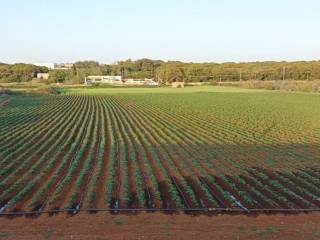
[0,87,320,213]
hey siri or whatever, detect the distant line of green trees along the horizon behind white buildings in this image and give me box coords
[0,59,320,83]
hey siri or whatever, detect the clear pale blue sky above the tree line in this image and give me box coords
[0,0,320,63]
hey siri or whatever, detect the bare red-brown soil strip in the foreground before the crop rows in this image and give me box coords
[0,212,320,240]
